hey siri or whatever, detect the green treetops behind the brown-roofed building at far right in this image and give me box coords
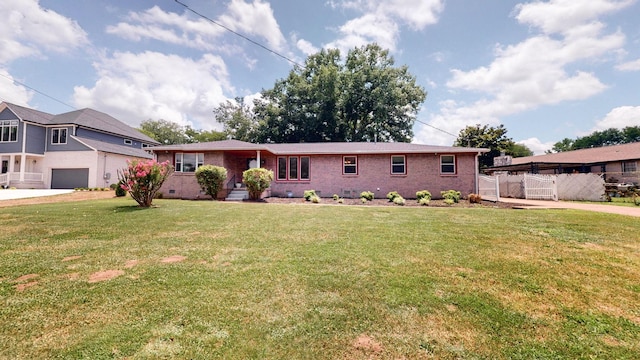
[547,126,640,153]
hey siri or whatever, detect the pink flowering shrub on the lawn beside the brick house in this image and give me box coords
[118,160,173,207]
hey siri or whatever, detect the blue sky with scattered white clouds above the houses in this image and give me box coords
[0,0,640,154]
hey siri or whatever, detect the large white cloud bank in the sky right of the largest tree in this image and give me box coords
[416,0,630,144]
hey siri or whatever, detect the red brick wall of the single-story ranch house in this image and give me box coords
[158,152,476,199]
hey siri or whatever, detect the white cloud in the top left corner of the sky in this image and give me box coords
[0,0,88,64]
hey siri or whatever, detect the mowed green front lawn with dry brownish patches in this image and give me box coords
[0,199,640,359]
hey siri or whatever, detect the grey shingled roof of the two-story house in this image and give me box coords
[4,102,160,144]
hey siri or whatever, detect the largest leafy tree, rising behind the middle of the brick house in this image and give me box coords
[254,44,426,143]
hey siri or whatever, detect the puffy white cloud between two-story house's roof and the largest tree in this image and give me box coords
[74,52,233,129]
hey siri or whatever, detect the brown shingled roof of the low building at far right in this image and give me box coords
[490,142,640,170]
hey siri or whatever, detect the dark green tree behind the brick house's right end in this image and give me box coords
[453,124,531,169]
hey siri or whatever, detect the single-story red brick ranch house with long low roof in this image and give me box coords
[151,140,488,199]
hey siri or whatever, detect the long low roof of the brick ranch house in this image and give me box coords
[151,140,489,155]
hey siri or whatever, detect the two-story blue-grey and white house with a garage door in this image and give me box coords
[0,102,159,189]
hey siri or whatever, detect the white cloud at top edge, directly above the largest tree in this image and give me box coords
[325,0,444,52]
